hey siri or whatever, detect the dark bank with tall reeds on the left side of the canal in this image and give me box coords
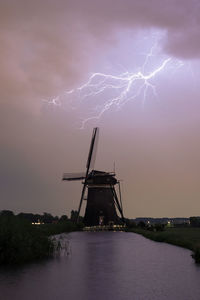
[0,216,81,265]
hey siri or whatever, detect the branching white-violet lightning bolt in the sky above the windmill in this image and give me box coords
[44,44,183,129]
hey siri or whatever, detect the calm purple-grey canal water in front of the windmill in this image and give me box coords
[0,232,200,300]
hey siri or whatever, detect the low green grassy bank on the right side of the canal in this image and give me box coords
[128,227,200,263]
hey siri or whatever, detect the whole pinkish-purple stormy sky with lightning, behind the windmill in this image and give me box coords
[0,0,200,218]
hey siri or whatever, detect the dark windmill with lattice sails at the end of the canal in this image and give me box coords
[62,127,124,226]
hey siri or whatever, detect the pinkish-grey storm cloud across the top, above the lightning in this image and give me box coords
[0,0,200,109]
